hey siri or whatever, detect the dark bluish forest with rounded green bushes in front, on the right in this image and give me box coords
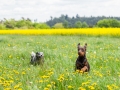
[46,14,120,28]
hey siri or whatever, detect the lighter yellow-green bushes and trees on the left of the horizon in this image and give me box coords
[0,17,50,29]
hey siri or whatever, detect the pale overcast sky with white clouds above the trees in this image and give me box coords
[0,0,120,22]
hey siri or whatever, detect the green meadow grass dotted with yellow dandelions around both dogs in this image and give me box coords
[0,35,120,90]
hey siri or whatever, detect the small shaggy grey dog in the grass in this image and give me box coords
[30,52,44,65]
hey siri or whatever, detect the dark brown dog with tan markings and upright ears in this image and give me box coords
[75,43,90,72]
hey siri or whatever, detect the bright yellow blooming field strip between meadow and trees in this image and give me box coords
[0,28,120,36]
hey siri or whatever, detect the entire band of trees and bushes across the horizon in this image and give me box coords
[0,14,120,29]
